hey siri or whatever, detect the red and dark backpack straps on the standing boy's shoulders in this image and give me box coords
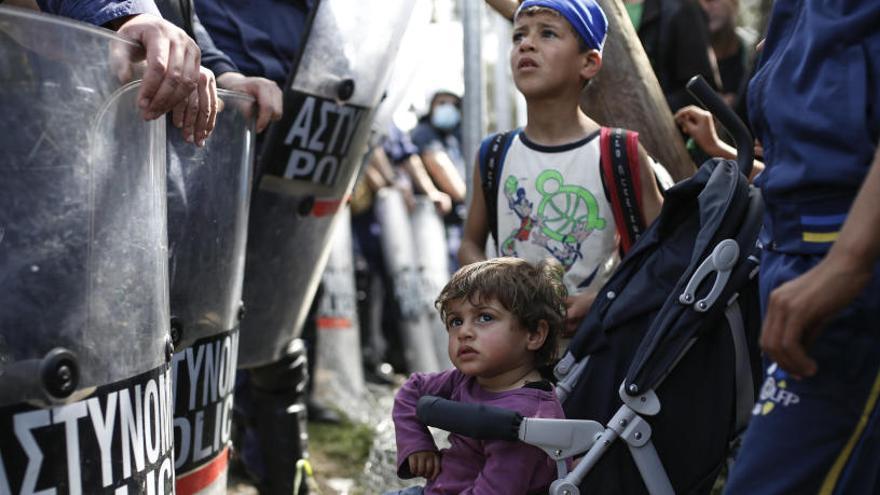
[478,127,645,254]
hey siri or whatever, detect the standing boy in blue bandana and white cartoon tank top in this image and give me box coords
[458,0,662,335]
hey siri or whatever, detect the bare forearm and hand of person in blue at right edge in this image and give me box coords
[761,253,872,378]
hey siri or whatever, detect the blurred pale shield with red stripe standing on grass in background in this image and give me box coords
[315,207,367,419]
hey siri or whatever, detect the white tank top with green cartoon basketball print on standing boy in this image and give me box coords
[497,131,619,294]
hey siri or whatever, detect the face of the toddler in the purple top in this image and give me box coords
[444,298,546,388]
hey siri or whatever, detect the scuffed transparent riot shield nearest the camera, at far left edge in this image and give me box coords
[0,7,174,494]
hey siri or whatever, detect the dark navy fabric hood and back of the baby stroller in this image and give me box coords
[555,154,763,494]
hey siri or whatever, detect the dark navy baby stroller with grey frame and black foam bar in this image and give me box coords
[419,77,763,495]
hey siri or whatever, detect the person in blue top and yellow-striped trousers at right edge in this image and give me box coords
[726,0,880,494]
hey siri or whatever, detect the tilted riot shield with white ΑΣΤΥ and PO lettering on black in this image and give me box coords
[239,0,414,368]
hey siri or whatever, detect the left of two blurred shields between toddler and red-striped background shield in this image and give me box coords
[375,187,446,372]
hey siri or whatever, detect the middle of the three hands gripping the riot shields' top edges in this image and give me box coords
[171,67,222,146]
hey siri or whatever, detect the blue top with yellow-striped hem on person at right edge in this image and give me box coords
[748,0,880,254]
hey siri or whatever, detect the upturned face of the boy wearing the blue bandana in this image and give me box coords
[510,12,598,98]
